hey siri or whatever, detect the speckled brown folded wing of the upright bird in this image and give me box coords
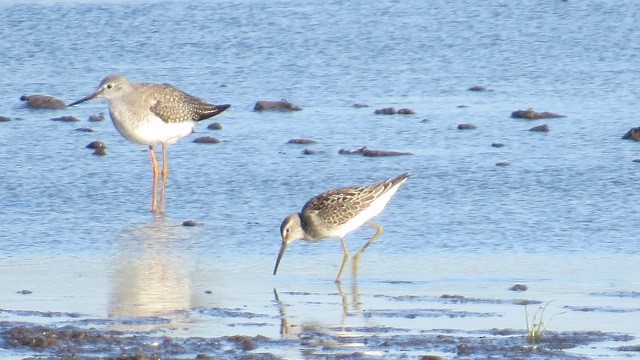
[148,84,229,123]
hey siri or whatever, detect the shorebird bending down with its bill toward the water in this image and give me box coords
[273,173,409,282]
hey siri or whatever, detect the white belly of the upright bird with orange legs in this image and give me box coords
[111,112,195,145]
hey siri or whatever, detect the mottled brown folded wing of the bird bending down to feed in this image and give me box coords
[302,174,408,226]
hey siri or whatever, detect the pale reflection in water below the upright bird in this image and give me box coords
[108,217,199,331]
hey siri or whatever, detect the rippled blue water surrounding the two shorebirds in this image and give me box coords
[0,0,640,358]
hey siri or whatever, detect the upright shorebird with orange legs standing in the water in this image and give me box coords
[69,75,230,212]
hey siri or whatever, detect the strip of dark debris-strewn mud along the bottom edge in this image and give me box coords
[0,321,638,360]
